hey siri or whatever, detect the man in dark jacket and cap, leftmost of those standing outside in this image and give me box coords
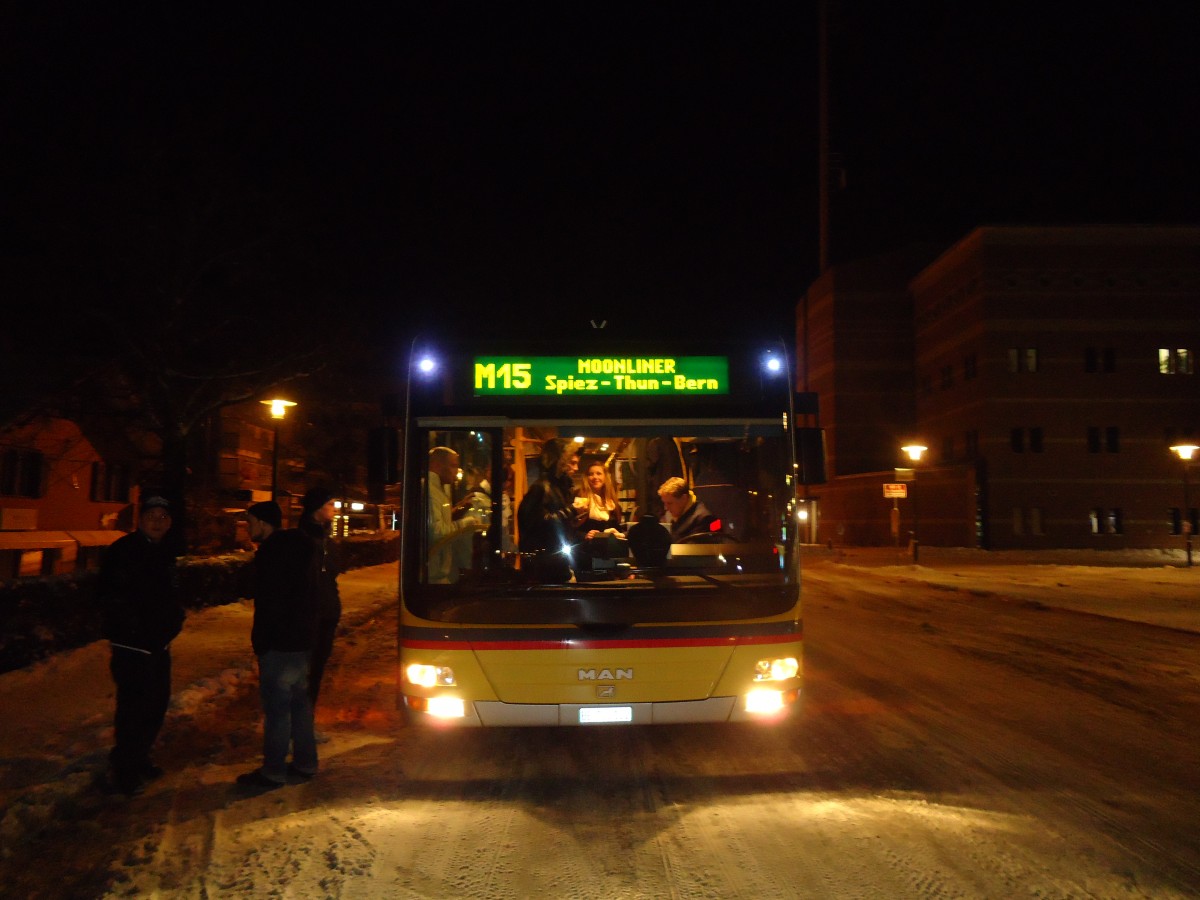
[97,497,184,796]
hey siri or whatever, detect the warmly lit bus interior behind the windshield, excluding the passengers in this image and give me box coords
[417,419,798,620]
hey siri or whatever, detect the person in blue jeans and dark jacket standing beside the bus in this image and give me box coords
[238,500,318,791]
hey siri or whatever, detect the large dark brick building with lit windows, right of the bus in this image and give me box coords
[797,226,1200,550]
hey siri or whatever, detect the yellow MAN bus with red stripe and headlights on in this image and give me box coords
[398,332,820,727]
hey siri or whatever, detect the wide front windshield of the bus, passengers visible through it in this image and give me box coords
[407,418,796,623]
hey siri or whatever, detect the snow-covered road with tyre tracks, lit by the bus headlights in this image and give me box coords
[0,564,1200,898]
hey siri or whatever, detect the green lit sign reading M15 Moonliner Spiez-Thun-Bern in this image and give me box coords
[474,356,730,398]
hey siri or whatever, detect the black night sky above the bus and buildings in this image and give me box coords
[0,0,1200,350]
